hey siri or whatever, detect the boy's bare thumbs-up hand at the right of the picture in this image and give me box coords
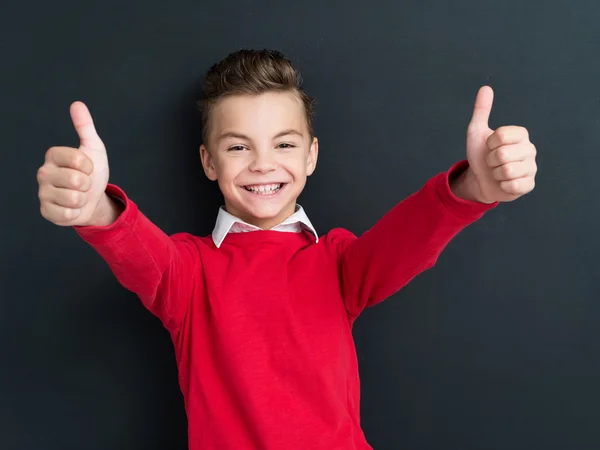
[454,86,537,203]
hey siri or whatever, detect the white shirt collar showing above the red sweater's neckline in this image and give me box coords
[212,205,319,248]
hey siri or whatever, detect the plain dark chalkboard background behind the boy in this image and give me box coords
[0,0,600,450]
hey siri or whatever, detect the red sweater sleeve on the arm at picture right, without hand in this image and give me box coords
[332,161,497,320]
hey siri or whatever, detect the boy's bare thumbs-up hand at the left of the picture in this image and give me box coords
[37,102,109,226]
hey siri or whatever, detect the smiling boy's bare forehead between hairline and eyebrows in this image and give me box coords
[211,92,307,136]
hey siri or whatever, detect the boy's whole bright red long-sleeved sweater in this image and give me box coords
[76,161,495,450]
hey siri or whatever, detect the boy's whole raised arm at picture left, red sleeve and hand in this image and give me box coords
[37,102,200,332]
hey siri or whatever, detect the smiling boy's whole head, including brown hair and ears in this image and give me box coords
[198,50,318,229]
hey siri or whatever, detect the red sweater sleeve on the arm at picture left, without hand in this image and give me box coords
[74,184,201,332]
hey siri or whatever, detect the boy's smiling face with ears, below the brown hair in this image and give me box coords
[200,92,318,229]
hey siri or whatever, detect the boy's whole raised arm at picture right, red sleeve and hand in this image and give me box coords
[336,86,537,318]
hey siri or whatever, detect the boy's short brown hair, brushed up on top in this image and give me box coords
[197,49,315,144]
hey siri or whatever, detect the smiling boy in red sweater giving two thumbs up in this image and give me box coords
[38,50,537,450]
